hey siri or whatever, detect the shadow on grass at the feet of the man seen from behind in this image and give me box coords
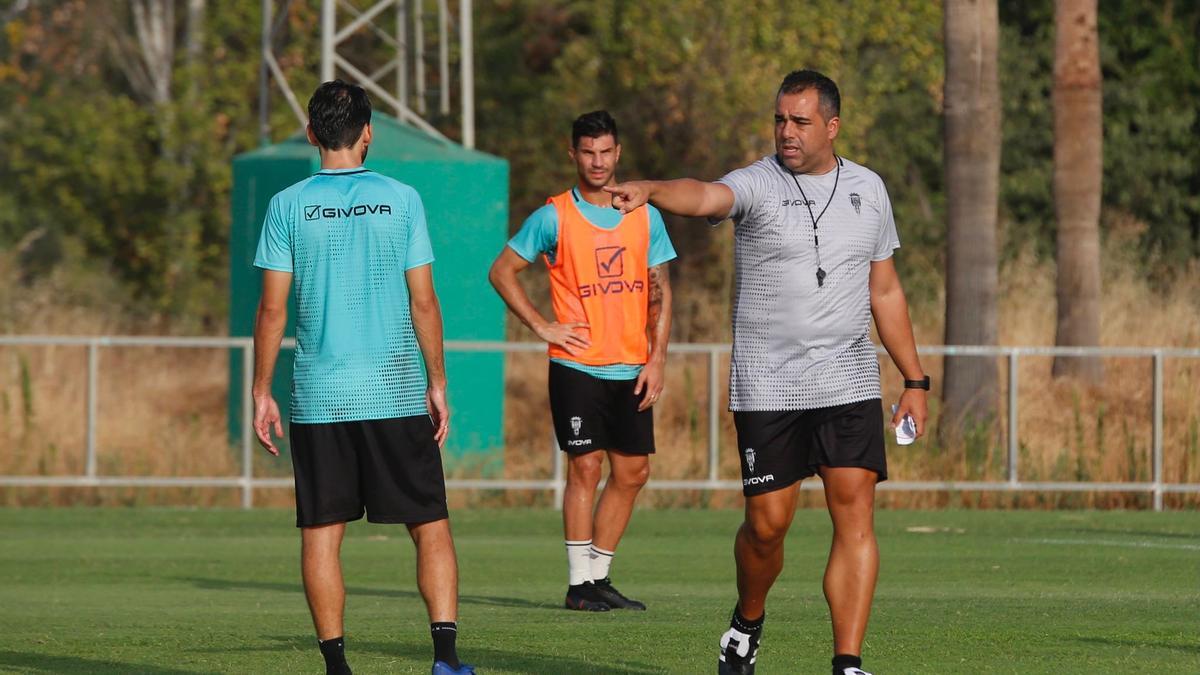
[347,641,666,675]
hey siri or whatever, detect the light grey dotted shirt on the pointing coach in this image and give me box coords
[718,155,900,411]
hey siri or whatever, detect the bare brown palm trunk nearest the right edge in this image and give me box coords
[1054,0,1104,383]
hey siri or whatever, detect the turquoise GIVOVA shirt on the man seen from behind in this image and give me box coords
[254,168,433,424]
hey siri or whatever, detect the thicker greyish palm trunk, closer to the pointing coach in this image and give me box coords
[940,0,1001,440]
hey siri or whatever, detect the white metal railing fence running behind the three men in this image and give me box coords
[0,335,1200,510]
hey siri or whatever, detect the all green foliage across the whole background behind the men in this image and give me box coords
[0,0,1200,326]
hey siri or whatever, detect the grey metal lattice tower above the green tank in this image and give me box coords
[258,0,475,148]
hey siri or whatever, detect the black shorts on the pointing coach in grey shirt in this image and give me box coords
[733,399,888,497]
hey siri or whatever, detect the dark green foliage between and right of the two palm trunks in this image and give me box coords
[1000,0,1200,265]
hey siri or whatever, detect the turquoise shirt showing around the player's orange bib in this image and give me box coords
[509,187,677,380]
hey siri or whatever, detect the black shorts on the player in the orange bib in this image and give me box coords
[550,362,654,455]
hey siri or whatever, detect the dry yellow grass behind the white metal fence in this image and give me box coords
[0,235,1200,507]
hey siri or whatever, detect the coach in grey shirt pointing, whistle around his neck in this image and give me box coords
[606,71,929,675]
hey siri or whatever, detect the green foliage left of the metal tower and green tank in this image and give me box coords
[0,1,312,321]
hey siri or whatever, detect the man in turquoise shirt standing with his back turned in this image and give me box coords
[252,80,474,675]
